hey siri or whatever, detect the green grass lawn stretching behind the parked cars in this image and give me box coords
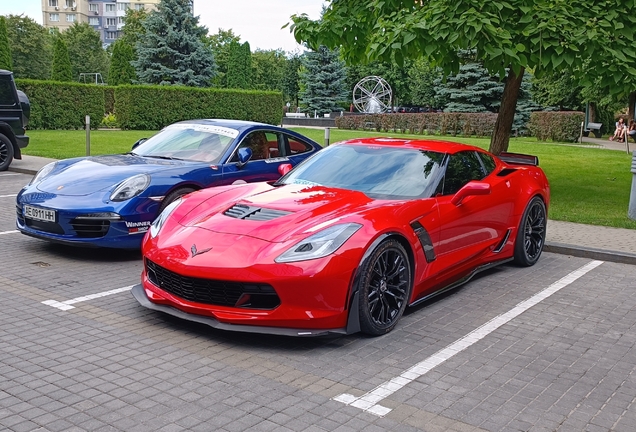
[24,128,636,229]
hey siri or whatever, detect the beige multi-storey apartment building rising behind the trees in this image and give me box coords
[42,0,159,45]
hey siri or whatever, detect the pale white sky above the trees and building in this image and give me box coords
[0,0,326,52]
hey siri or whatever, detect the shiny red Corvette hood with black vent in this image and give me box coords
[179,185,380,242]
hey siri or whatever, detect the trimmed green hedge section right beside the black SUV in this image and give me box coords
[15,79,104,129]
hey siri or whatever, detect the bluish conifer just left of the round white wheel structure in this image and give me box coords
[299,46,347,114]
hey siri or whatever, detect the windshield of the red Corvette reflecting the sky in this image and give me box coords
[278,144,445,199]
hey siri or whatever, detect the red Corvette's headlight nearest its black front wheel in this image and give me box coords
[274,223,362,263]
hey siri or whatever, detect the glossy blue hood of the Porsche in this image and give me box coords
[37,155,188,196]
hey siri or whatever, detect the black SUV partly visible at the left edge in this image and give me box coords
[0,69,31,171]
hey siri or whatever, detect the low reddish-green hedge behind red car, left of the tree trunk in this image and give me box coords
[336,113,497,137]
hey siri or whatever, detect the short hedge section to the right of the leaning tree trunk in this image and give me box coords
[528,111,585,142]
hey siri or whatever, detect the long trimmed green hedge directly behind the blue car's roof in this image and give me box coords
[115,85,283,130]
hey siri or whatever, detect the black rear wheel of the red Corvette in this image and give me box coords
[514,196,548,267]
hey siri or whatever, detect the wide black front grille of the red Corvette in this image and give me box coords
[145,259,280,309]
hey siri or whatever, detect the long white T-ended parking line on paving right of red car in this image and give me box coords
[333,261,603,417]
